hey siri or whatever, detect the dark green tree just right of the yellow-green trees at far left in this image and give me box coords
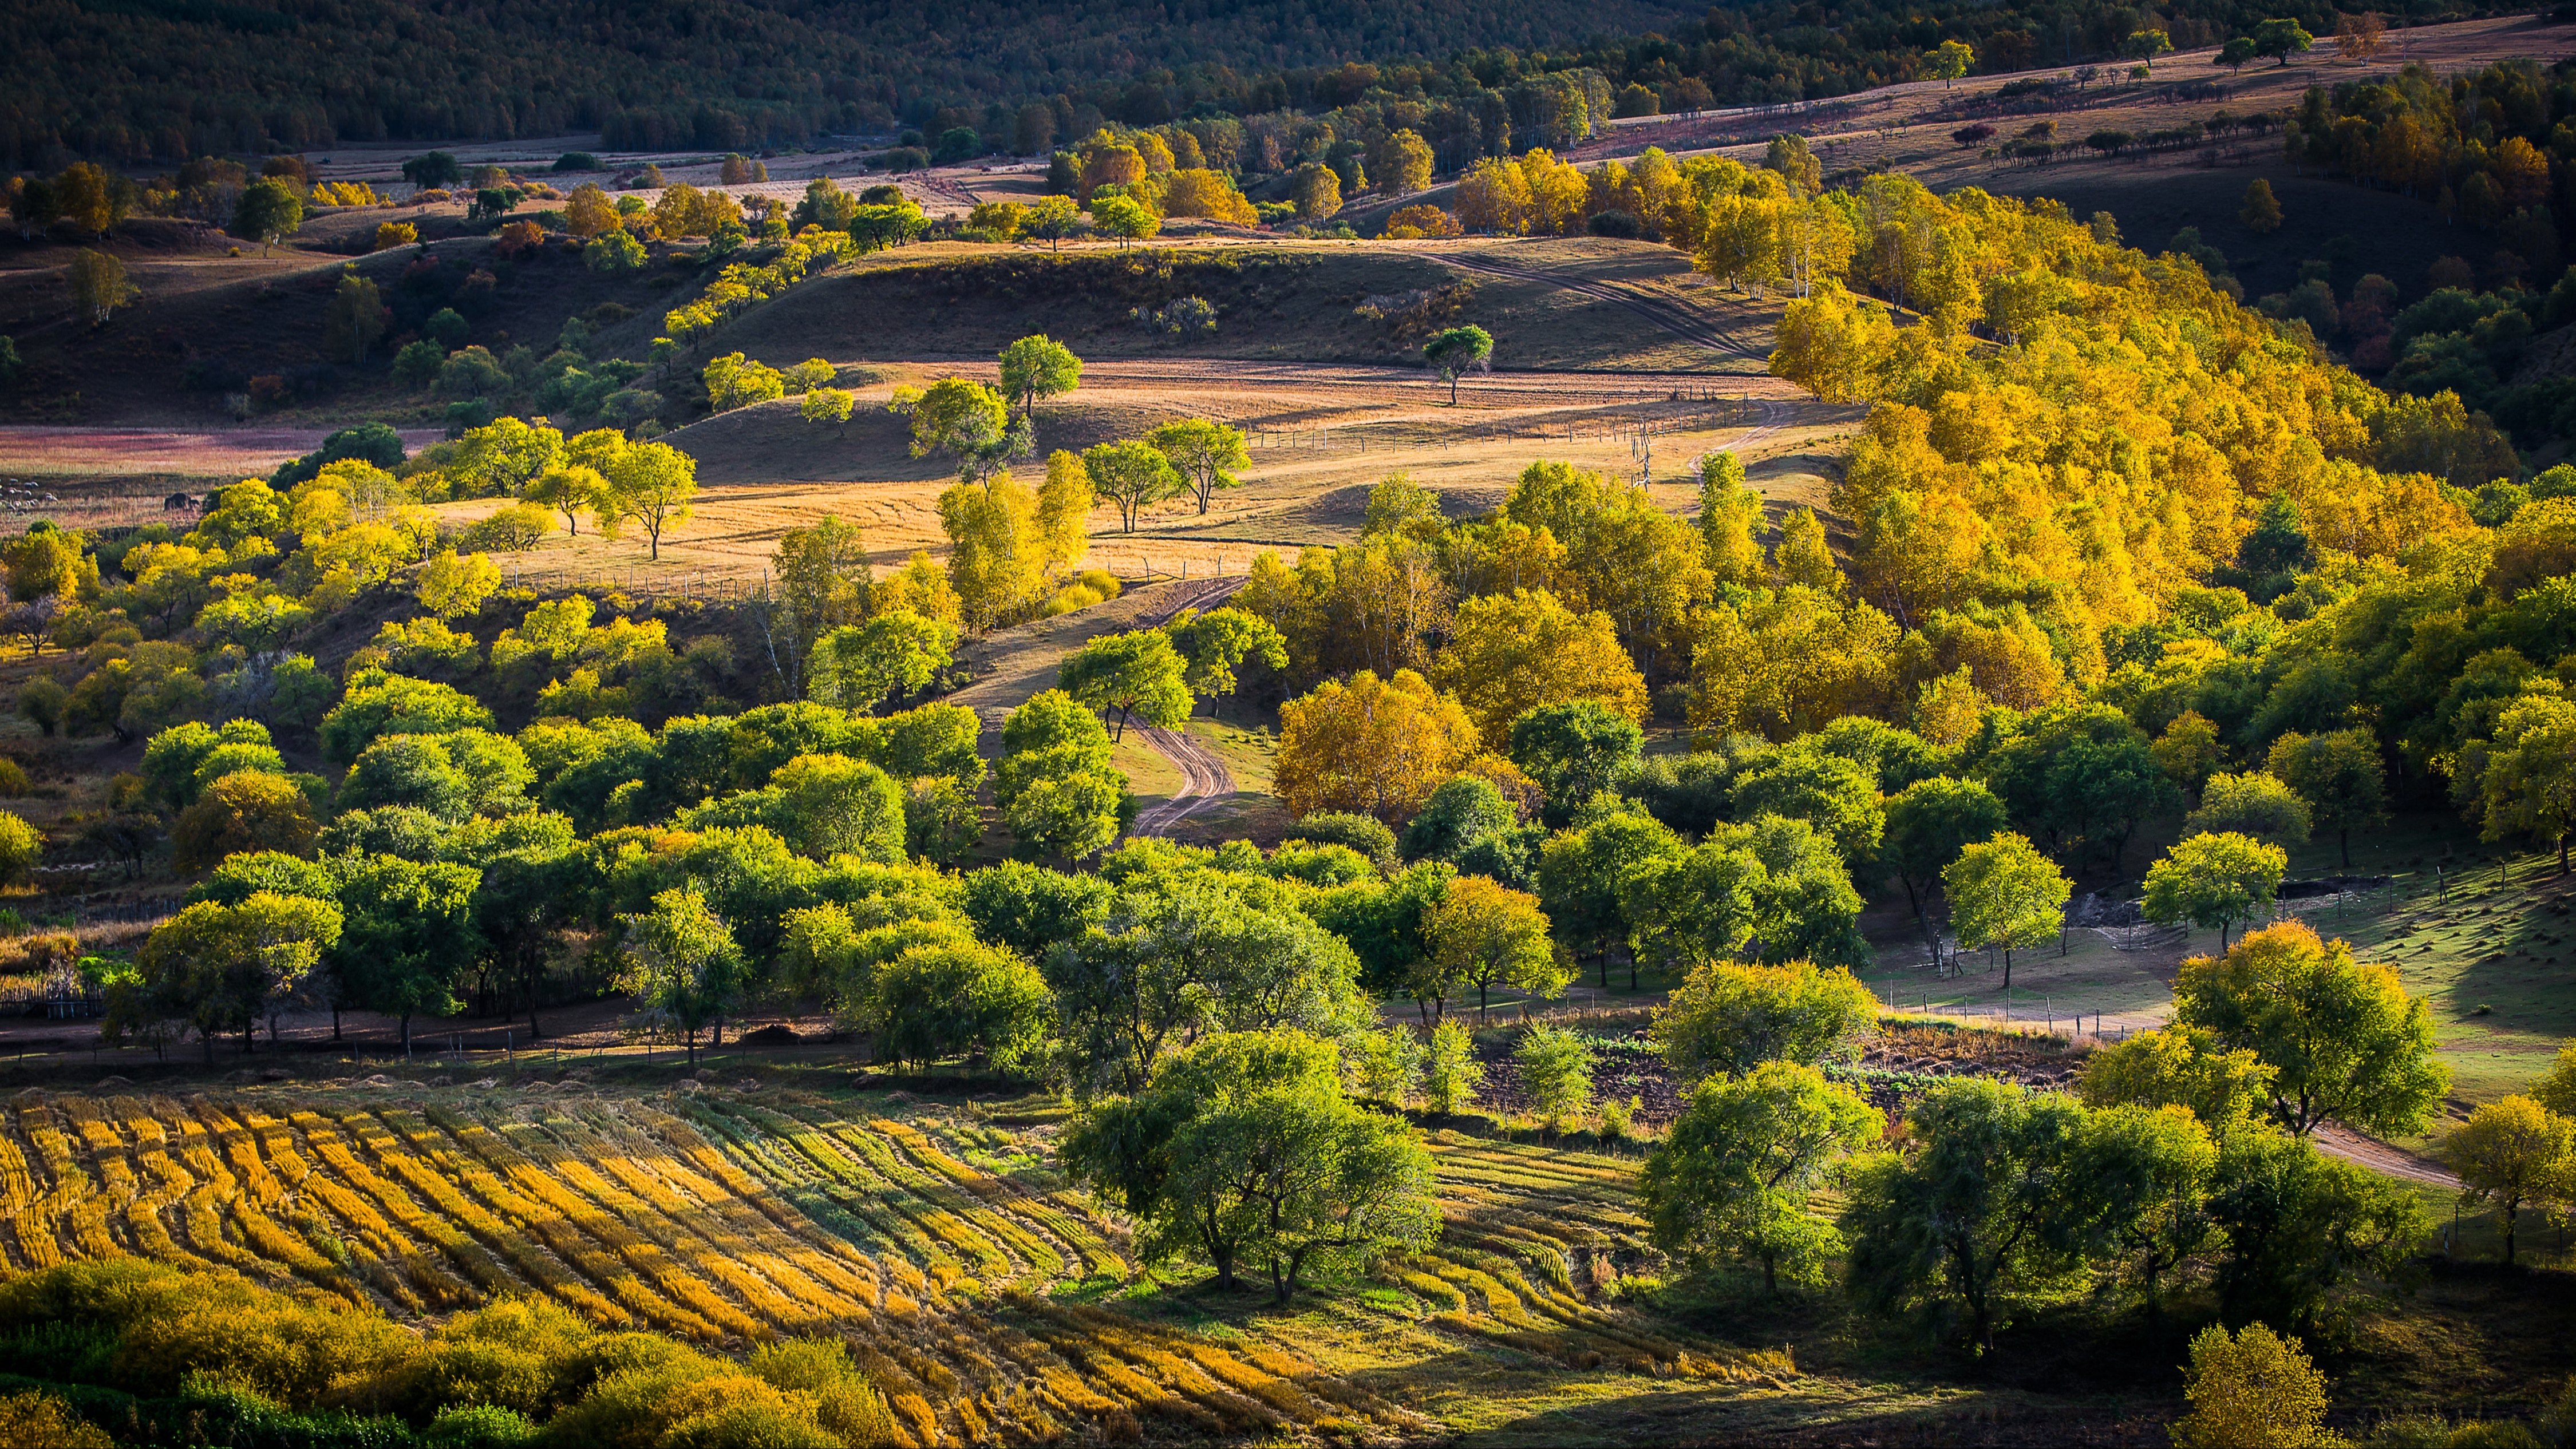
[330,854,482,1055]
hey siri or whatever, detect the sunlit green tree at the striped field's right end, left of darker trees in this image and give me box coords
[1638,1060,1878,1297]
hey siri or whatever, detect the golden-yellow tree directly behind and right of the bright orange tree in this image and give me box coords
[1435,589,1646,751]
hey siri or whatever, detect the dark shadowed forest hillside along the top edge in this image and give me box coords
[0,0,2524,170]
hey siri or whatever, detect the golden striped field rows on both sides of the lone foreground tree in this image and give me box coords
[0,1083,1785,1444]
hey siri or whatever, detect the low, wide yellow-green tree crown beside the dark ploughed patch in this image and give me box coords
[1654,960,1878,1083]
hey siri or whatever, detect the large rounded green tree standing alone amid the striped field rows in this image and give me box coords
[1064,1032,1440,1302]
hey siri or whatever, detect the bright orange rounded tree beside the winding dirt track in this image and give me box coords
[1273,669,1481,826]
